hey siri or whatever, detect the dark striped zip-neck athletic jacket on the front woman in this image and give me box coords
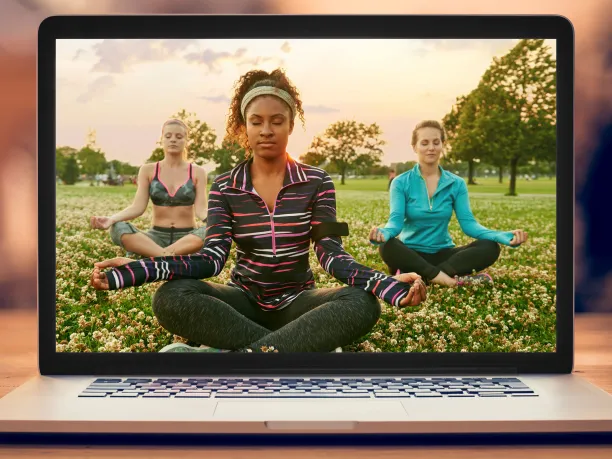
[106,155,411,310]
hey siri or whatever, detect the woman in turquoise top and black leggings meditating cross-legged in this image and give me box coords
[369,120,527,287]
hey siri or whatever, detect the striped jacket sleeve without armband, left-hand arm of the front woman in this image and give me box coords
[105,183,232,290]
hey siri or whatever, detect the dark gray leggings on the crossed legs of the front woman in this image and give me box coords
[153,279,381,352]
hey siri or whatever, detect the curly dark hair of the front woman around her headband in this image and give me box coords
[226,69,304,158]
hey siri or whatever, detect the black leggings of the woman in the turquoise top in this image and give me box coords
[379,238,500,282]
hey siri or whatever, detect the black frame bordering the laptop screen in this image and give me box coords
[37,15,574,375]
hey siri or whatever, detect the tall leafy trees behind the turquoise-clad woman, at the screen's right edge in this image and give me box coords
[443,40,557,195]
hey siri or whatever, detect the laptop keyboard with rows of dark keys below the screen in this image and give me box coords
[79,378,538,399]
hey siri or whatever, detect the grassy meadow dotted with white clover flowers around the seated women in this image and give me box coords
[56,185,556,352]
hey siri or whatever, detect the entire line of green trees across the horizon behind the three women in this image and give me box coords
[56,40,556,195]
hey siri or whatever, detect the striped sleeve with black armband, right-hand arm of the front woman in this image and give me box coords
[311,174,411,306]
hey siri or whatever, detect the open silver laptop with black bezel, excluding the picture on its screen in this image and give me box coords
[0,16,612,434]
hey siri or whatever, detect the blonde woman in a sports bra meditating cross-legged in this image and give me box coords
[90,119,208,257]
